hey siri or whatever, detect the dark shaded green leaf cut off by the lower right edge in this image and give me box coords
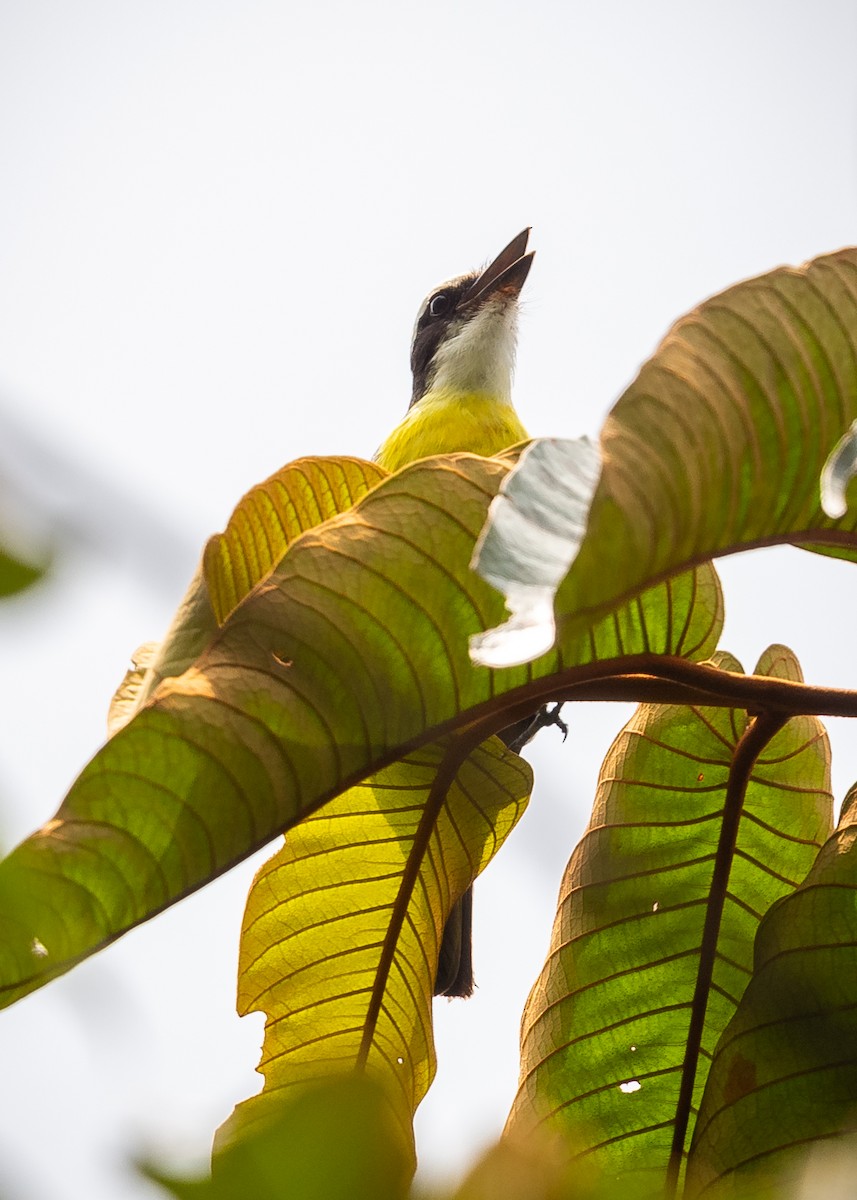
[688,786,857,1196]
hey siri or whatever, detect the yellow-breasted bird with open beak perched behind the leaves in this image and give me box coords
[374,228,532,997]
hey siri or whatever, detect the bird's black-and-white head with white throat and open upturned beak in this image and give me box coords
[410,229,534,407]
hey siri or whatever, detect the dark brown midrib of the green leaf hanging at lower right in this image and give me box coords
[664,713,787,1198]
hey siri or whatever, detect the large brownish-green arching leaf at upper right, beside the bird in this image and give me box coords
[557,248,857,620]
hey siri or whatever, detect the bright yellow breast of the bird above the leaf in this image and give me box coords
[376,391,528,470]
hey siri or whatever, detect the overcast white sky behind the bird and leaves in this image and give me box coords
[0,0,857,1200]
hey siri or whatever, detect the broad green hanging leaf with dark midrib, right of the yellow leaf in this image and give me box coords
[510,647,831,1195]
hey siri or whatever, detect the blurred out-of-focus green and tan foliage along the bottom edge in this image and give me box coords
[139,1075,857,1200]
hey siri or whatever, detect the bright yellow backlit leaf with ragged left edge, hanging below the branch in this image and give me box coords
[220,738,532,1156]
